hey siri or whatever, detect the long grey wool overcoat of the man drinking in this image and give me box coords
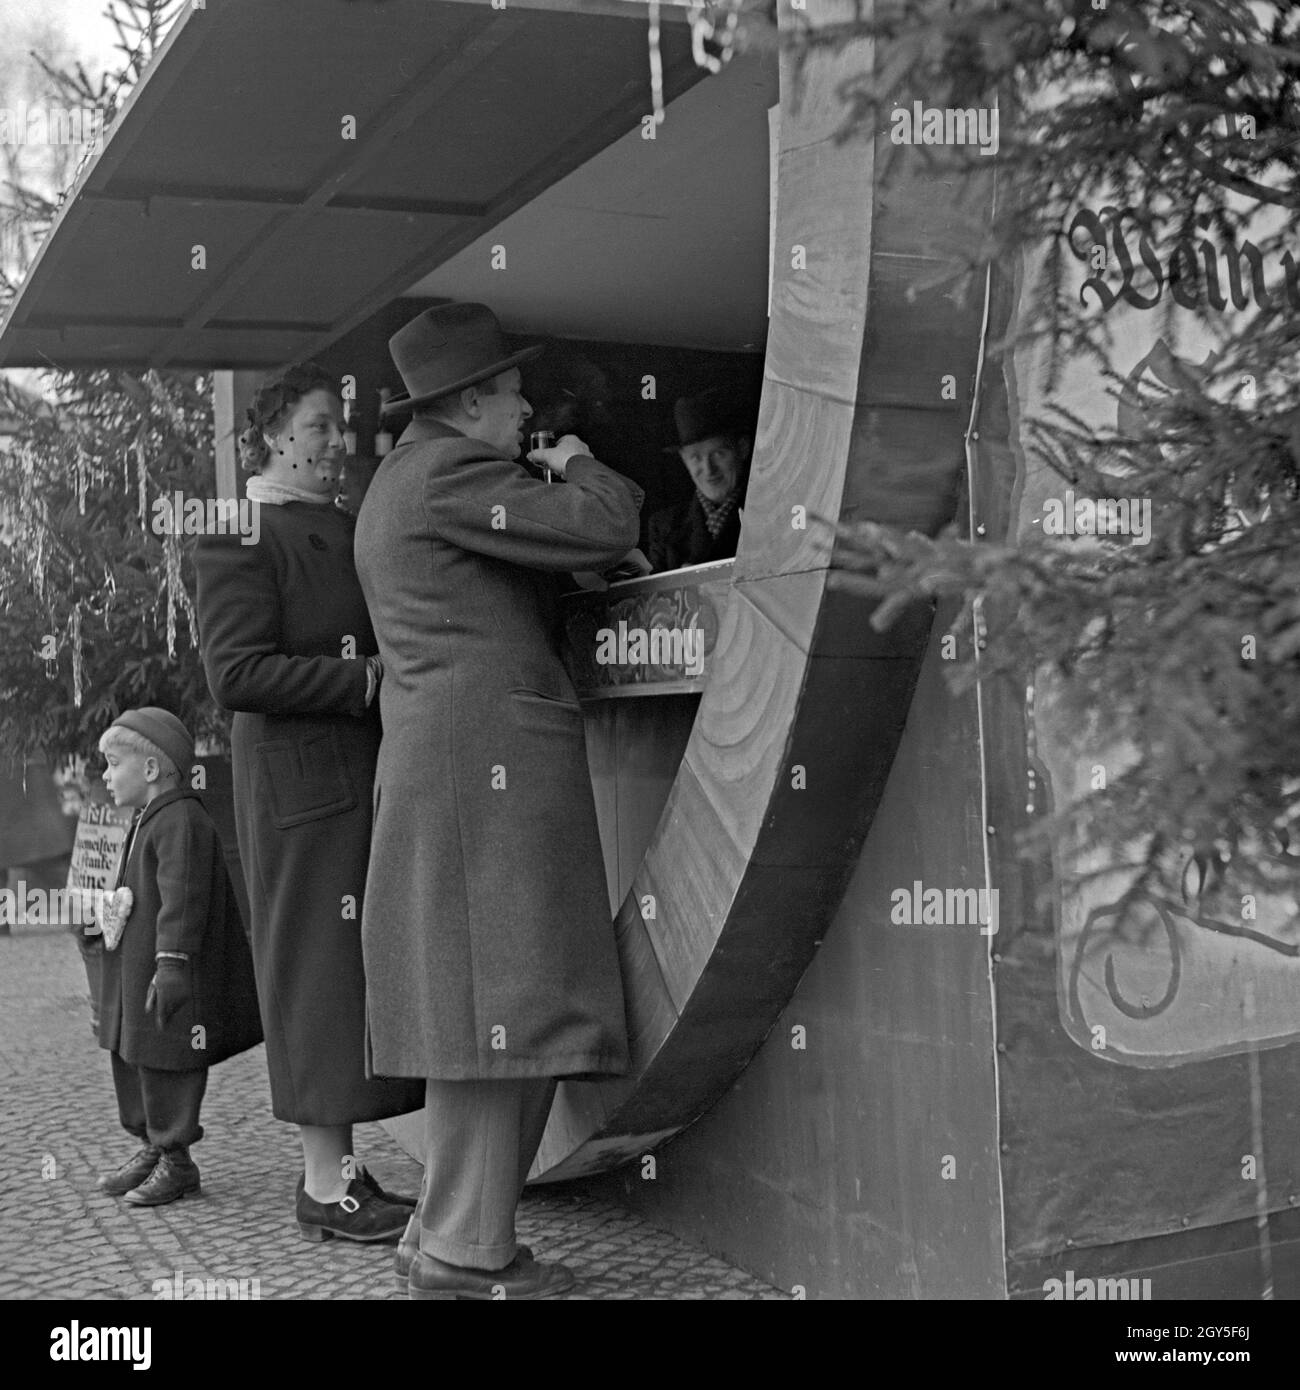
[356,420,642,1080]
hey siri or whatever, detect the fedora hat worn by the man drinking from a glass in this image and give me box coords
[380,304,542,416]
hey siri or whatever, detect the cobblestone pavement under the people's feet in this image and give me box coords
[0,927,788,1300]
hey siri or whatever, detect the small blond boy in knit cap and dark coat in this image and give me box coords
[99,708,261,1207]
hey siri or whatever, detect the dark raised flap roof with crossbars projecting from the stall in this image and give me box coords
[0,0,722,368]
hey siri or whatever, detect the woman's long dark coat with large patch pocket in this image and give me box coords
[196,502,424,1125]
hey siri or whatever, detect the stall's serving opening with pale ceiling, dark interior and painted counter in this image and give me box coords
[321,38,779,910]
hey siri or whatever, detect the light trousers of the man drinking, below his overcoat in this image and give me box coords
[413,1076,556,1269]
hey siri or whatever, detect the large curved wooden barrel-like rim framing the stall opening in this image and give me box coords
[531,0,990,1182]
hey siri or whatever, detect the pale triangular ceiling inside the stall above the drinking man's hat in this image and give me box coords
[409,54,779,352]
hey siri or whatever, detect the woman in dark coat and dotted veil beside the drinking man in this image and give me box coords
[196,364,424,1240]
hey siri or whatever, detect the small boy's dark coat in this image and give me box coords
[99,789,261,1072]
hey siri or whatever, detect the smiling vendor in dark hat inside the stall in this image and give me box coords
[645,386,754,570]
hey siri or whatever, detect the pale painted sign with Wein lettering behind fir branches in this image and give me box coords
[1009,157,1300,1066]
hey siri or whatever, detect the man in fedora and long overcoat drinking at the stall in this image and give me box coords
[356,304,642,1298]
